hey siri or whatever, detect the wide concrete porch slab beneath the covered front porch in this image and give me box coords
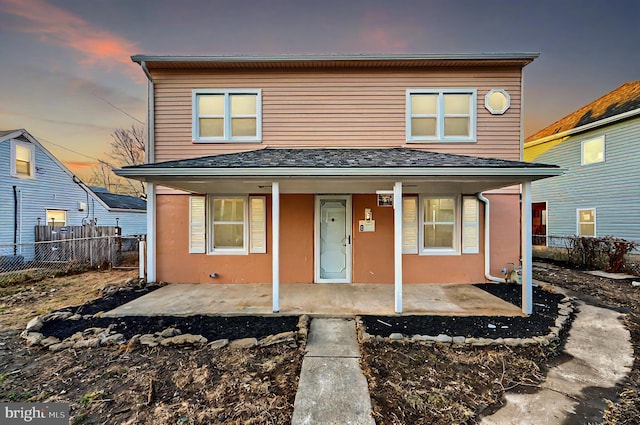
[105,283,523,317]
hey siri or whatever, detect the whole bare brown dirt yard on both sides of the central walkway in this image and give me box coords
[0,264,640,425]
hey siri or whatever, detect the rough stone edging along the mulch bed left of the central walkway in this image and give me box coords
[20,311,309,352]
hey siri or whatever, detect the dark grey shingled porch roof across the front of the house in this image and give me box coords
[122,148,557,170]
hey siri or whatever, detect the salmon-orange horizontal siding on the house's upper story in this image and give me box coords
[153,68,521,161]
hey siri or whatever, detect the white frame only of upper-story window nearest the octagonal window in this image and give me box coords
[406,87,478,143]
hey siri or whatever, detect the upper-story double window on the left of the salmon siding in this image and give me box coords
[192,89,262,142]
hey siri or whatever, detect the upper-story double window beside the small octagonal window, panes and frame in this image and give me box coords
[407,89,477,142]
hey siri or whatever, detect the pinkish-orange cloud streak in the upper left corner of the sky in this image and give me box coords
[0,0,140,78]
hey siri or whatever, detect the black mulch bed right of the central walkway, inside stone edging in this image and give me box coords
[362,284,564,338]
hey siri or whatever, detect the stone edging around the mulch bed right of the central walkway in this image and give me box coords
[356,297,575,347]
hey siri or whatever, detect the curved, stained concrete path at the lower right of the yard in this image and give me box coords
[481,302,633,425]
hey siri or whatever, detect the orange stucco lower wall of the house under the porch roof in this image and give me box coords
[157,194,520,284]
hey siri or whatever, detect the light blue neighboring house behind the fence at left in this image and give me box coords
[0,130,146,259]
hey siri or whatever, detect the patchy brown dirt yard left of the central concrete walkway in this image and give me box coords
[0,272,304,424]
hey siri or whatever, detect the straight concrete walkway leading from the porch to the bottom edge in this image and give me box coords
[291,318,375,425]
